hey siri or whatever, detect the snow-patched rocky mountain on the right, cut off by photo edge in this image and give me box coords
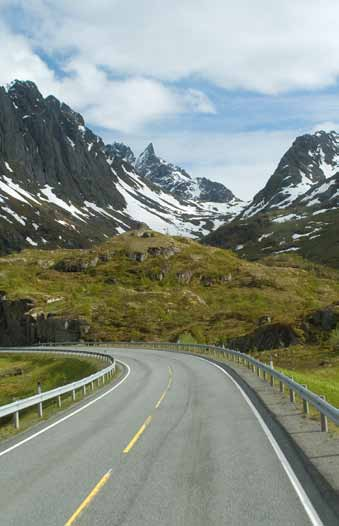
[205,131,339,267]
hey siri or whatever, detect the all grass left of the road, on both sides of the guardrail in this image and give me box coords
[0,353,122,440]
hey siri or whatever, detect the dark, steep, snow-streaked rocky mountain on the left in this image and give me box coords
[0,81,240,253]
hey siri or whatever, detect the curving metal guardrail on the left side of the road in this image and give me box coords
[0,346,115,429]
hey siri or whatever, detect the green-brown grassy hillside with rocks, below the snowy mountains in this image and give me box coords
[0,230,339,343]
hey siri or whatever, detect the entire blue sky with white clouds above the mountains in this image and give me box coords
[0,0,339,199]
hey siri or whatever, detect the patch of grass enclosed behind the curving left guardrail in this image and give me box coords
[0,353,102,405]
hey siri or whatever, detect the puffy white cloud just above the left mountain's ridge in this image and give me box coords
[0,23,215,132]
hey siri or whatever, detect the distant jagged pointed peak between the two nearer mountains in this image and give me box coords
[135,143,239,203]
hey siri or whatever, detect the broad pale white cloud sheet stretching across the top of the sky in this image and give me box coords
[12,0,339,94]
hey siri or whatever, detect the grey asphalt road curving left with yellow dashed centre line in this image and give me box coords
[0,350,327,526]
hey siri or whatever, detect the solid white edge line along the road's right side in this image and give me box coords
[196,356,324,526]
